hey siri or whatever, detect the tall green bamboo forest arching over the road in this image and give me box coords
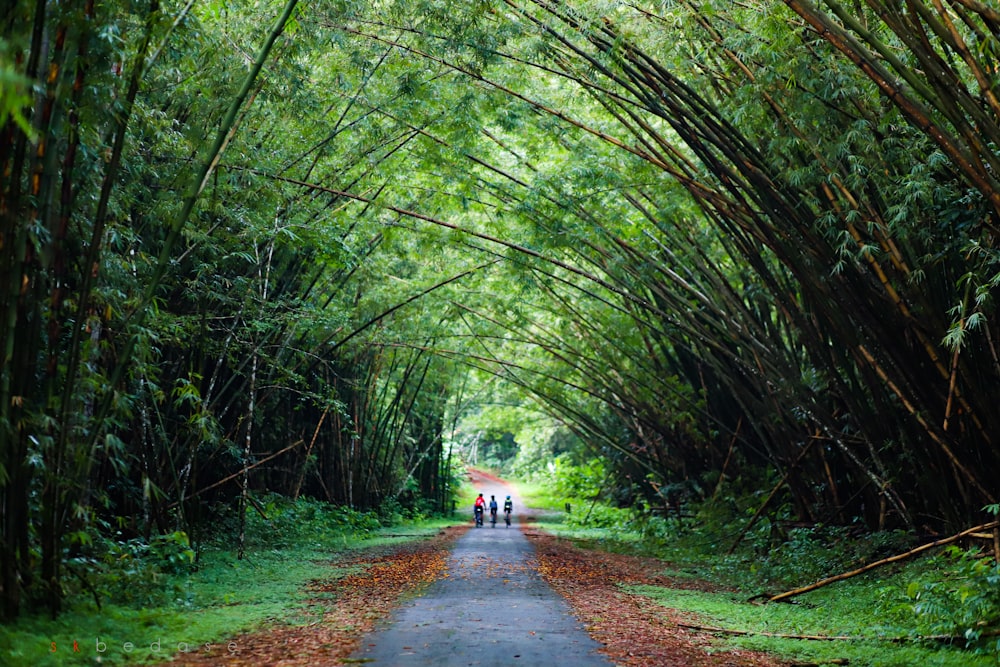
[0,0,1000,665]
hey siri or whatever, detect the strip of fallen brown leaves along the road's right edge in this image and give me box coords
[525,530,782,667]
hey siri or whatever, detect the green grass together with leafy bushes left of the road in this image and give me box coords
[0,496,452,667]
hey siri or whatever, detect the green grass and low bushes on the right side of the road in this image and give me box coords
[519,460,1000,667]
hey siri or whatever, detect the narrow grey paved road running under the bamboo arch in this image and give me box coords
[354,483,611,667]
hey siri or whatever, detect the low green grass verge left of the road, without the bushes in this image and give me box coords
[0,519,454,667]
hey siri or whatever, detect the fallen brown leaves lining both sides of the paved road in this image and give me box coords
[156,524,783,667]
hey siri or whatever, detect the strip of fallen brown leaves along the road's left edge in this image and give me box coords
[161,526,468,667]
